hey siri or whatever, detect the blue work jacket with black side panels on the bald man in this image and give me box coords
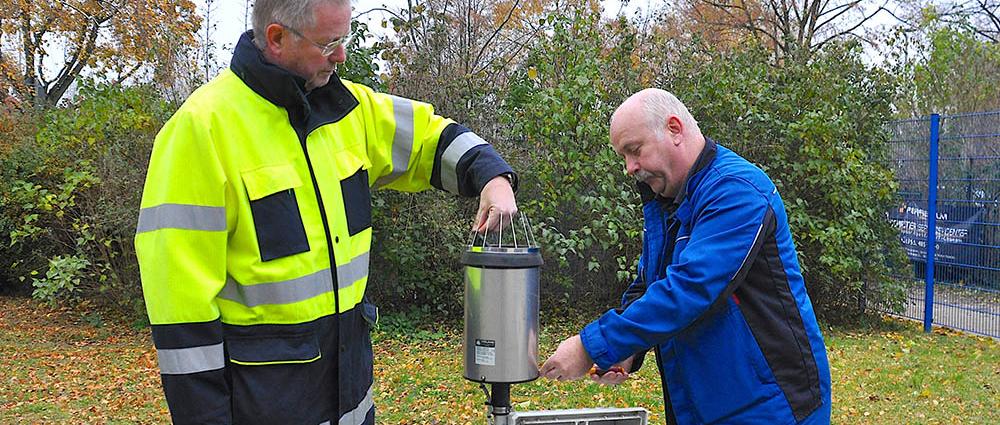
[580,139,830,425]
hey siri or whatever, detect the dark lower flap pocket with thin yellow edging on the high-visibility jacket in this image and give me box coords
[226,332,322,366]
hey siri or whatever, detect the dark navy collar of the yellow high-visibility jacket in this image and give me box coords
[229,30,358,137]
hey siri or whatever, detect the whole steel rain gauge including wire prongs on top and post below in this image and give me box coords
[462,213,542,423]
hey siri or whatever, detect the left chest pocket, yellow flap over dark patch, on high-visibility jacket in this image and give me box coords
[242,164,309,261]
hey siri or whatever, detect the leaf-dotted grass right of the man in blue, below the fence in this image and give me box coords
[827,320,1000,424]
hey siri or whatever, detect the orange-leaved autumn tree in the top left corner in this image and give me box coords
[0,0,201,106]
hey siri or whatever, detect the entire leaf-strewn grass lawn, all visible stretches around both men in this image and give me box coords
[0,297,1000,425]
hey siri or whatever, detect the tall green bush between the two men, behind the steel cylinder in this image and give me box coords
[504,7,642,308]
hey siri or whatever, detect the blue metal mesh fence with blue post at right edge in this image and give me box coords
[876,111,1000,338]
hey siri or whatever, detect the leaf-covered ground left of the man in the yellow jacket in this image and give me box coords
[0,298,169,423]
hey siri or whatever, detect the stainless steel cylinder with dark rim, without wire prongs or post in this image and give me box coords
[462,247,542,384]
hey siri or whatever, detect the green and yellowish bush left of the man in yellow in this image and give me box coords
[0,83,173,313]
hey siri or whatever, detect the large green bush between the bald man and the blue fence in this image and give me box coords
[662,43,905,321]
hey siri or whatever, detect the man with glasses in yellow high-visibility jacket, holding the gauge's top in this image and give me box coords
[135,0,517,425]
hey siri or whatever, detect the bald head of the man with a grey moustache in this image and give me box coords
[611,89,705,197]
